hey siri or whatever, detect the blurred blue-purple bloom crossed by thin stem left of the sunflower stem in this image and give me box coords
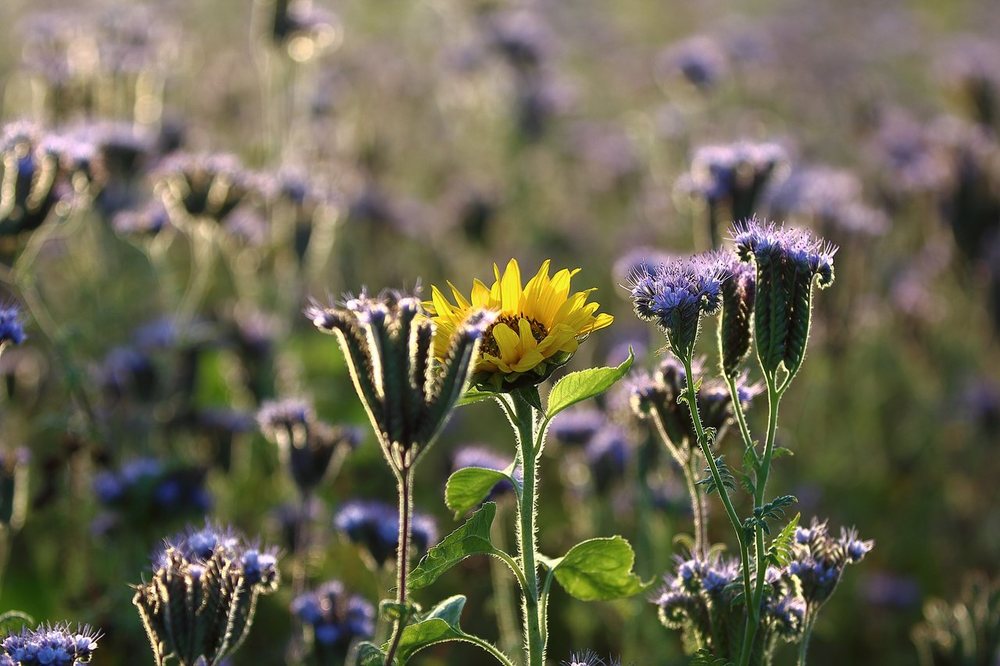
[333,500,437,567]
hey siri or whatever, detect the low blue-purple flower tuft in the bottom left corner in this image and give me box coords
[0,623,101,666]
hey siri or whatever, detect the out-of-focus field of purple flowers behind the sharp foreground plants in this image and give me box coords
[0,0,1000,666]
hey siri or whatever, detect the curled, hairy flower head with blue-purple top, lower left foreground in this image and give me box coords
[132,524,278,666]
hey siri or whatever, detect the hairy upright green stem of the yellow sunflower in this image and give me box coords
[511,394,545,666]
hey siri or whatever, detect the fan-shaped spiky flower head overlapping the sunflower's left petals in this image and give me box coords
[306,291,493,471]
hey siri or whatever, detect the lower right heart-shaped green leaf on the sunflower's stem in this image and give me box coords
[552,536,649,601]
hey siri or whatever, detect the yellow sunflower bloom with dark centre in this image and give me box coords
[426,259,614,391]
